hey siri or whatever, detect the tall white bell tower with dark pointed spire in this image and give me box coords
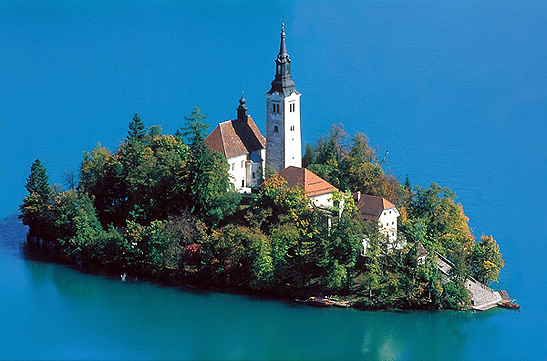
[266,24,302,172]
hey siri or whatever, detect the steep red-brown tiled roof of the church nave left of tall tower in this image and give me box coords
[205,116,266,158]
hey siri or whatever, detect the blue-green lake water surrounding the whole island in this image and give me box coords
[0,1,547,360]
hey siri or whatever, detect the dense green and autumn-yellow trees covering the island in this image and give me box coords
[20,118,503,308]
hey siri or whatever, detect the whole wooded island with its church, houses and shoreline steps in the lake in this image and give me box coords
[20,25,508,310]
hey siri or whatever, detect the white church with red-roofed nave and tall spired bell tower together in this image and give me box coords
[205,24,310,193]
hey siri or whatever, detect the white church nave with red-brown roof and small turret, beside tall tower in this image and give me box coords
[205,94,266,193]
